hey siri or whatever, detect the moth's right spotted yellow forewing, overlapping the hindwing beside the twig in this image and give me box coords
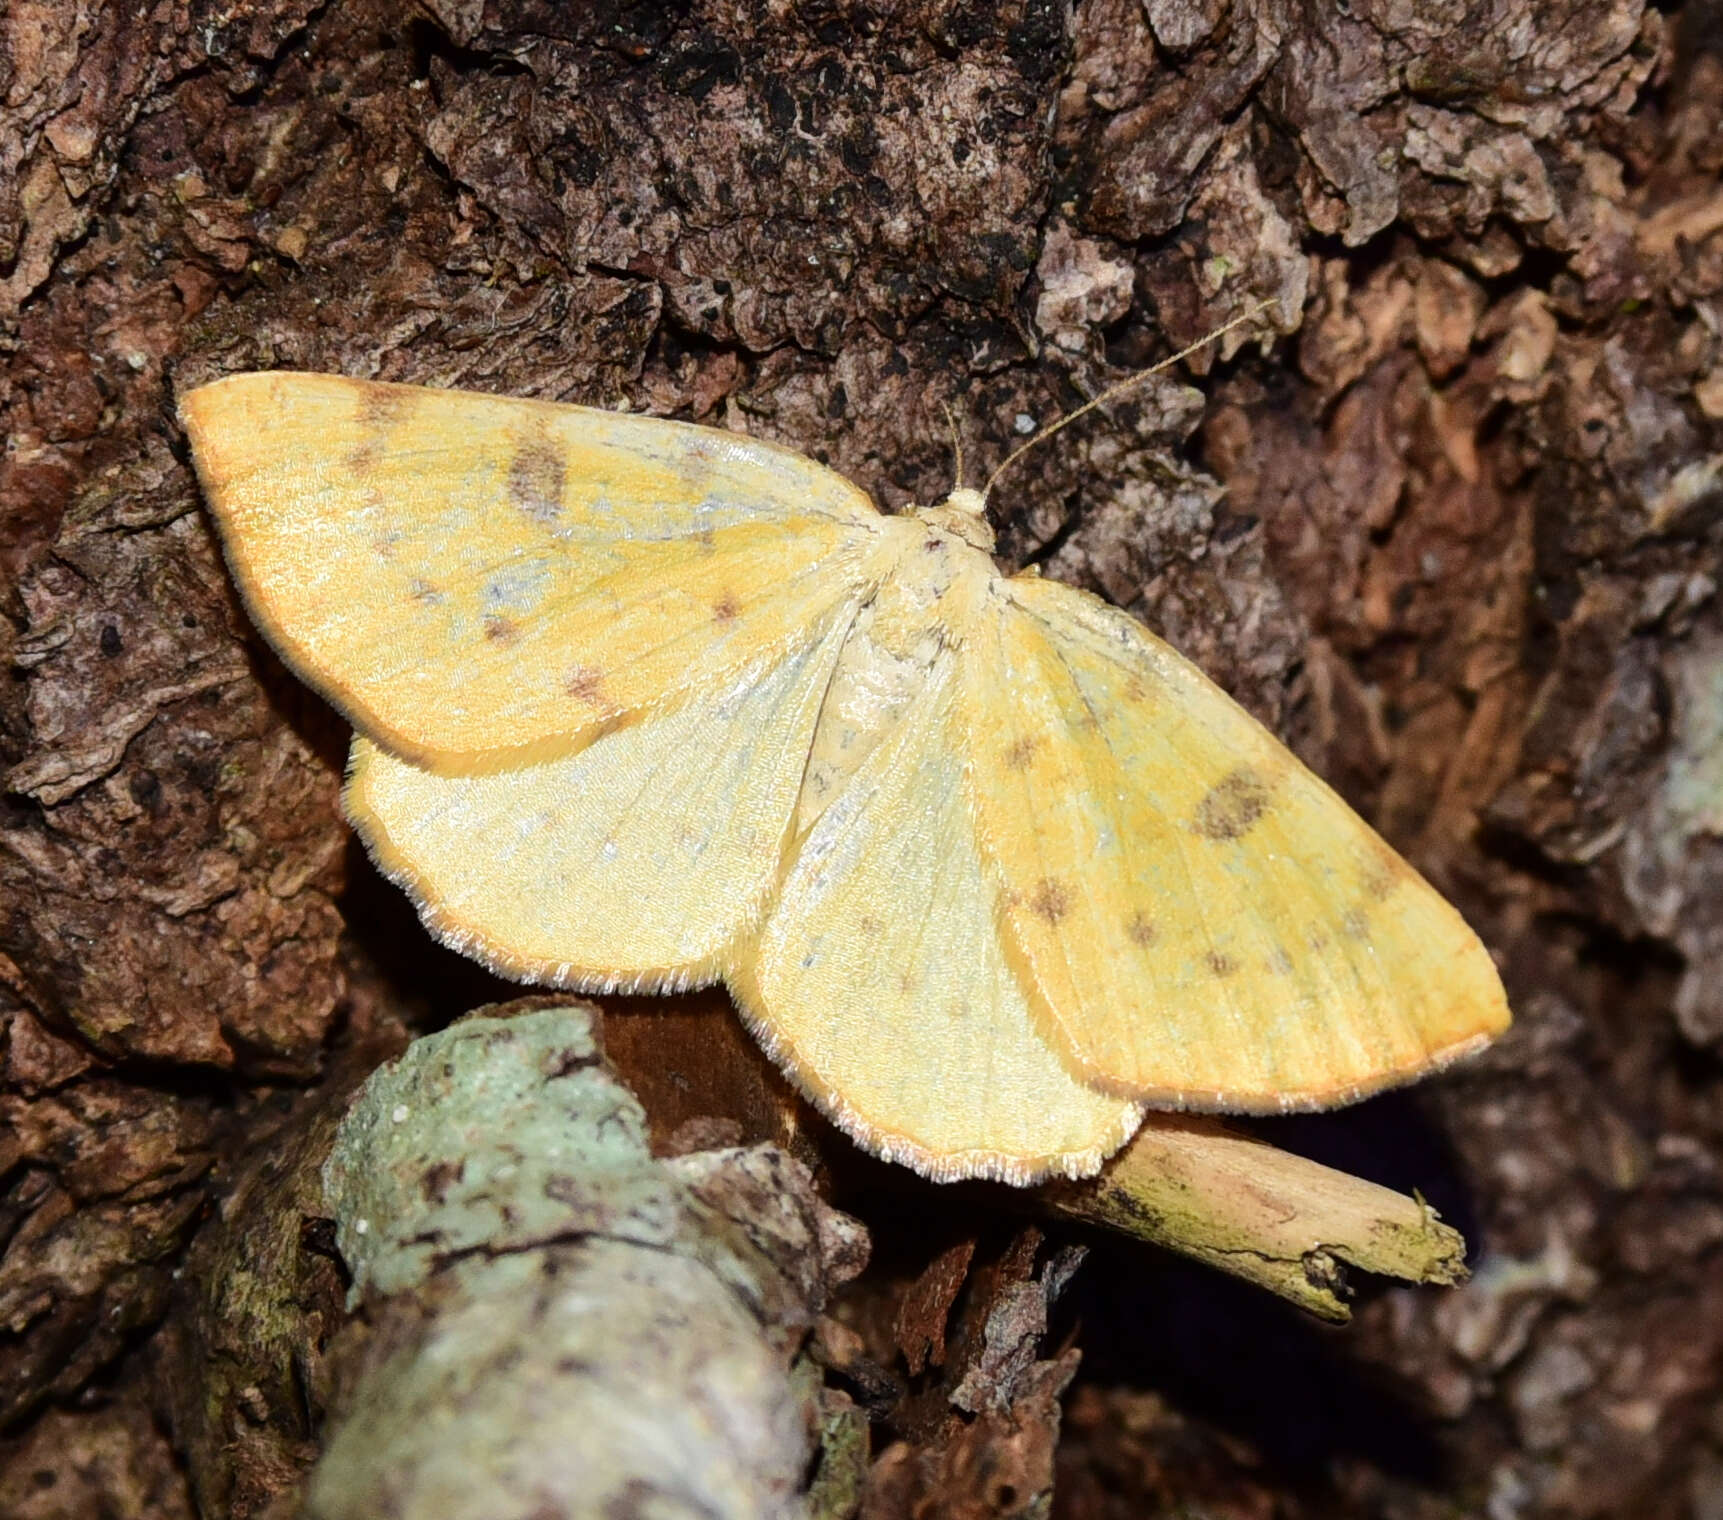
[958,577,1508,1112]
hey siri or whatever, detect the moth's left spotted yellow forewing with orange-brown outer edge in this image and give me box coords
[181,372,880,770]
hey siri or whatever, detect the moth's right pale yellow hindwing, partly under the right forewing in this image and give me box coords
[729,644,1142,1182]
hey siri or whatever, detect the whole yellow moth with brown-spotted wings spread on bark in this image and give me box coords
[181,372,1508,1182]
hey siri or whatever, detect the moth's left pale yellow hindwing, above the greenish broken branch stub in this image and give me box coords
[346,607,855,991]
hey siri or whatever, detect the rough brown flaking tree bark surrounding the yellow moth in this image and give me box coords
[0,0,1723,1517]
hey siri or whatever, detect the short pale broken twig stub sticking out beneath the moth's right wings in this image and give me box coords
[1041,1113,1466,1324]
